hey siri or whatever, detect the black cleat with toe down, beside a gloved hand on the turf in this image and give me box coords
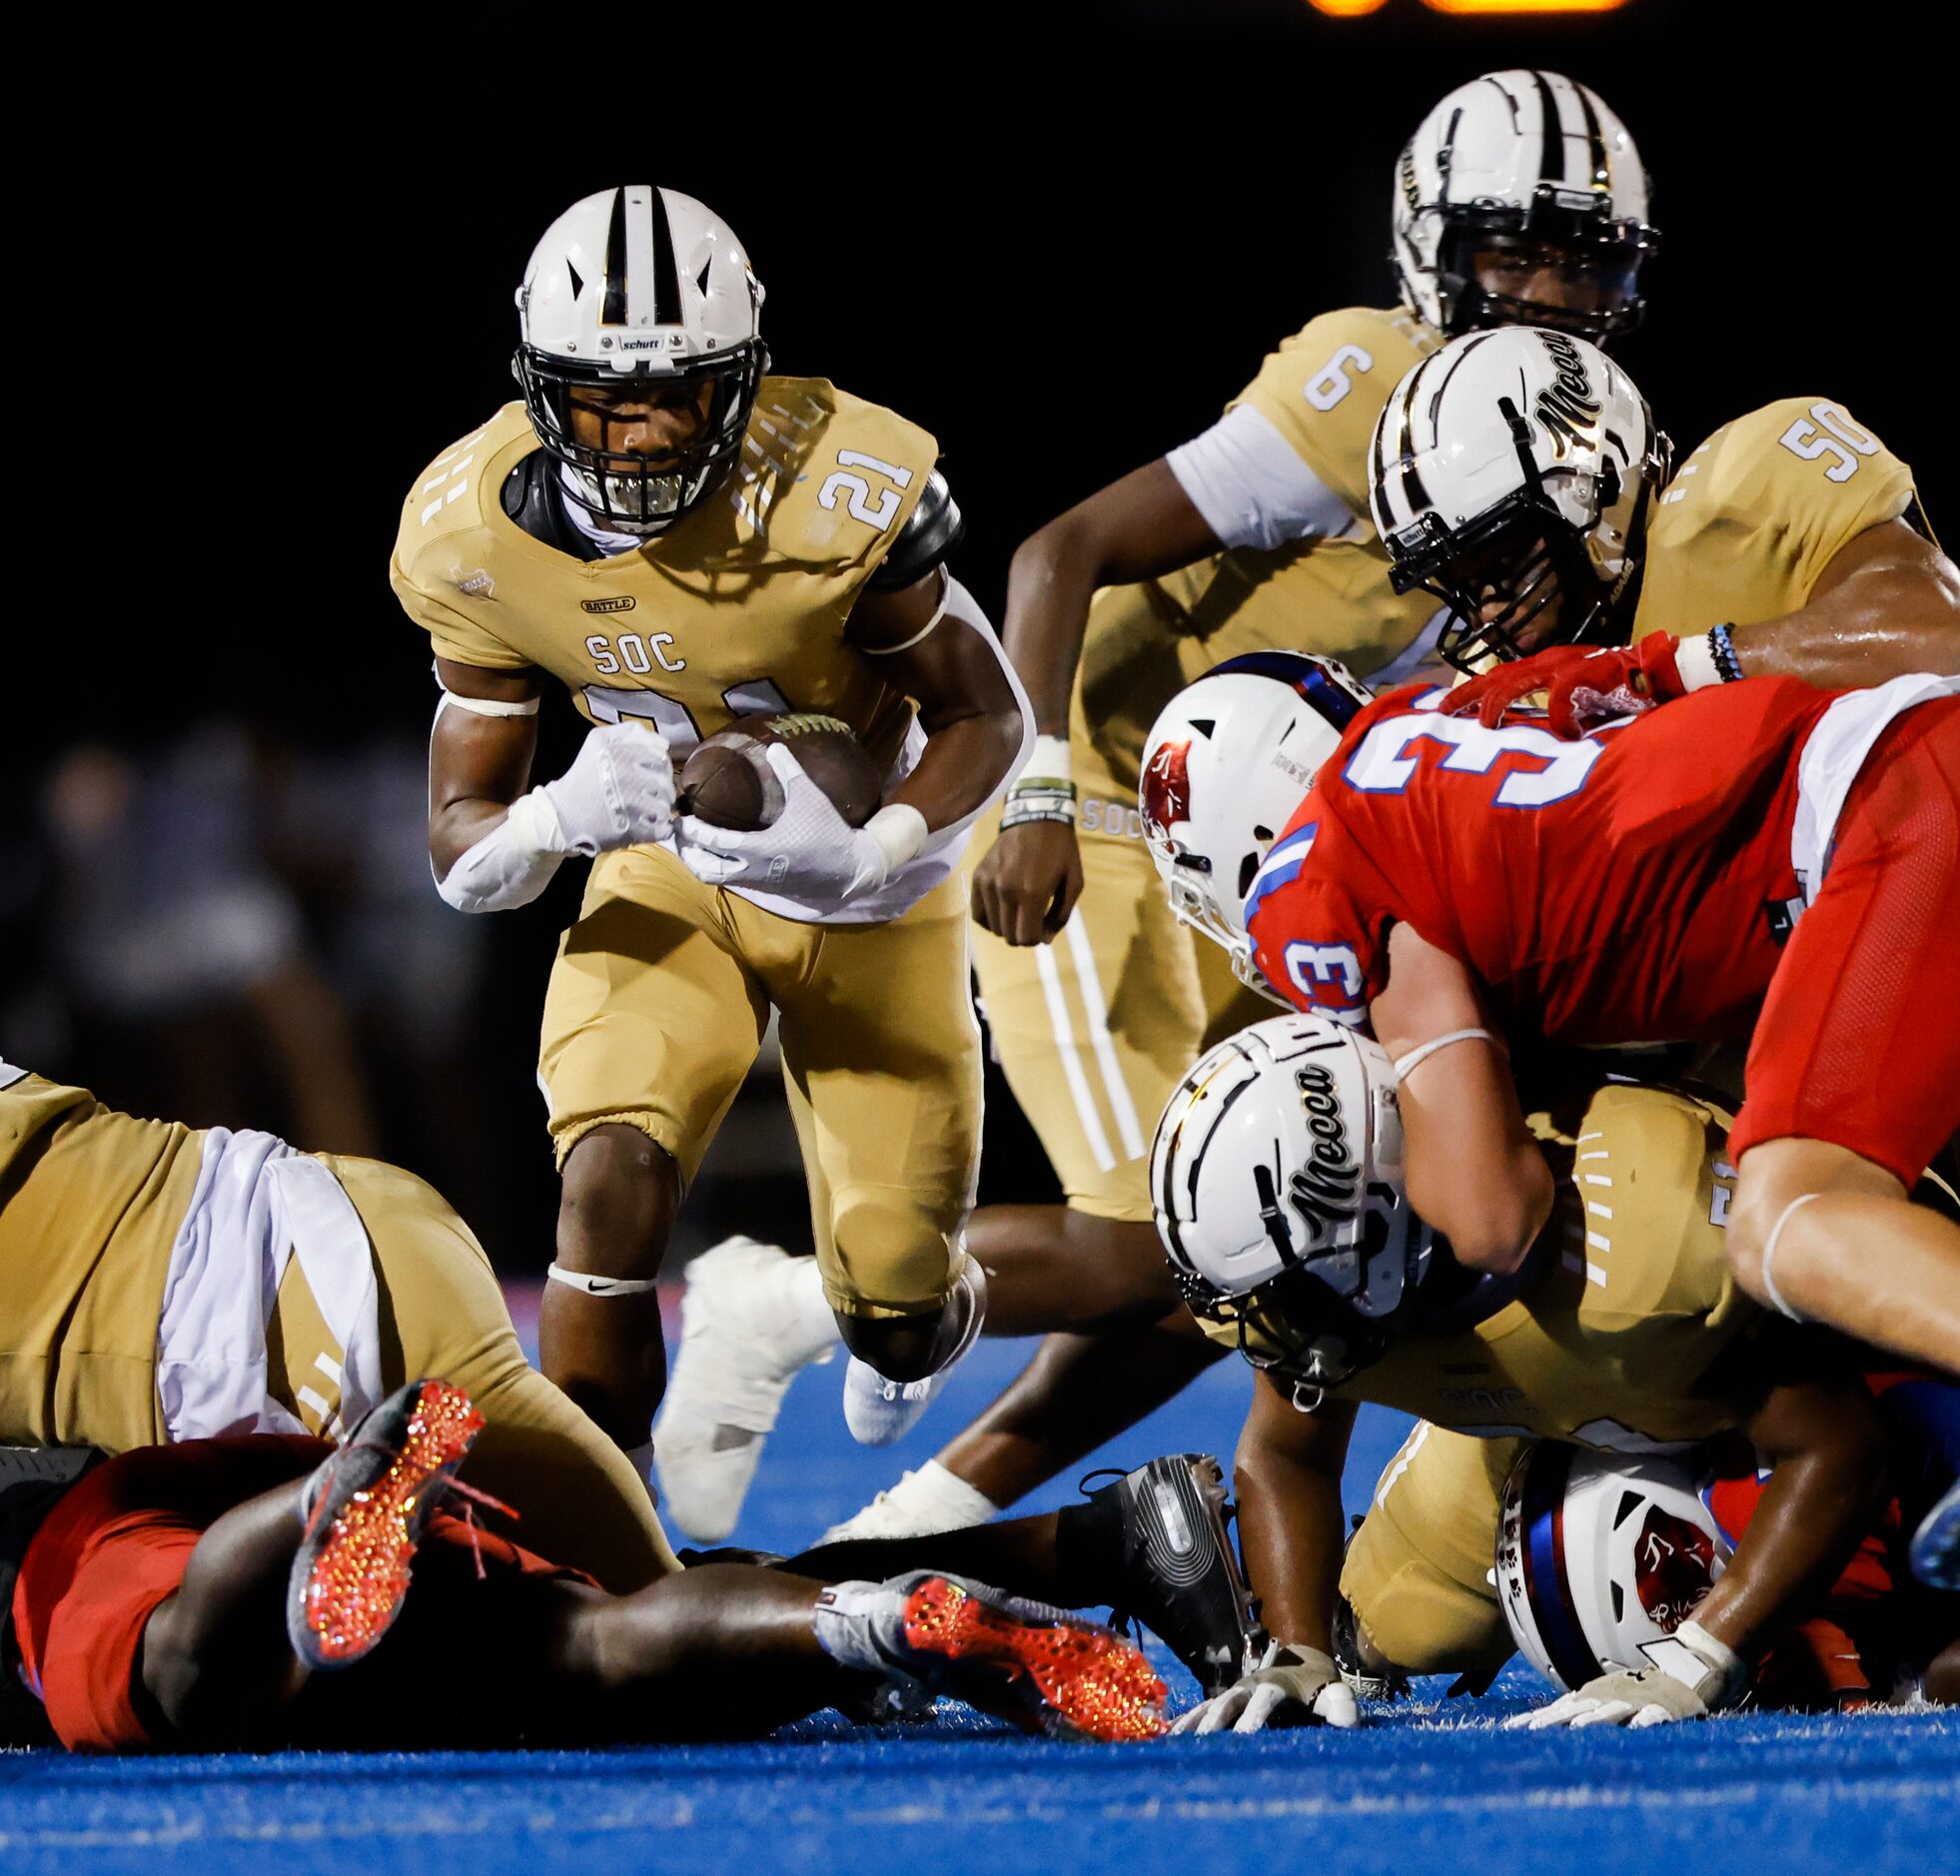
[1088,1452,1264,1699]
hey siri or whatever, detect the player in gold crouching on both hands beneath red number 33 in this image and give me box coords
[1151,1016,1944,1731]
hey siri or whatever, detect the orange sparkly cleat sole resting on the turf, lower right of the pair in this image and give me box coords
[903,1576,1164,1743]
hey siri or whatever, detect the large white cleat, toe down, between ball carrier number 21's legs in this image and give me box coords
[652,1237,837,1542]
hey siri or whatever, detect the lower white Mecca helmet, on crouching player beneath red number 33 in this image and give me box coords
[1151,1016,1433,1400]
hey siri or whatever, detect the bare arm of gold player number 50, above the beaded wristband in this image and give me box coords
[1730,556,1960,690]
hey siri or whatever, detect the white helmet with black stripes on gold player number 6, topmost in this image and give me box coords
[1394,71,1660,339]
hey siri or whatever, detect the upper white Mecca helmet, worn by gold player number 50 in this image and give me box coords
[1368,326,1672,670]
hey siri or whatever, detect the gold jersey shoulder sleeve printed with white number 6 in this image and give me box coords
[1229,306,1441,525]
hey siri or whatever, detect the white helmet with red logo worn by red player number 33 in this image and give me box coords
[1137,651,1374,996]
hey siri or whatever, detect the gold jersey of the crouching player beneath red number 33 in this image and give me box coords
[1199,1084,1756,1452]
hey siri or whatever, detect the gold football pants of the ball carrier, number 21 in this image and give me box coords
[539,847,980,1318]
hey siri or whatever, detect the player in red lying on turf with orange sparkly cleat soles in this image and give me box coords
[0,1382,1164,1750]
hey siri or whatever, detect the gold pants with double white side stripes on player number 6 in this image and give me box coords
[972,800,1276,1220]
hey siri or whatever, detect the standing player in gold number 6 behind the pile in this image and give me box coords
[843,71,1658,1535]
